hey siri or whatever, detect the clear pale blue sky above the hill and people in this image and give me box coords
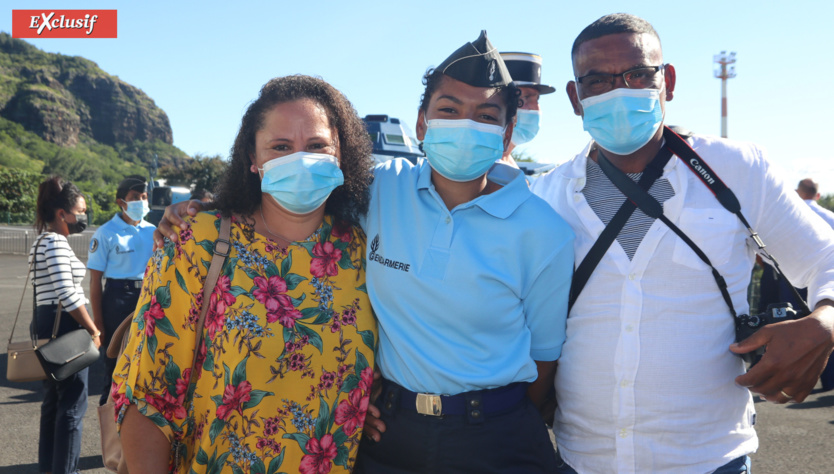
[0,0,834,194]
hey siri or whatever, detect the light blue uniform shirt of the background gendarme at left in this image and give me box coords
[87,213,156,280]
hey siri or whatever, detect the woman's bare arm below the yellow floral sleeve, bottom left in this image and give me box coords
[120,405,171,474]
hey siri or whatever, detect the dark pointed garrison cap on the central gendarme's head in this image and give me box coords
[436,30,512,87]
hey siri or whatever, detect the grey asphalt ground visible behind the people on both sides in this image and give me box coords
[0,255,834,474]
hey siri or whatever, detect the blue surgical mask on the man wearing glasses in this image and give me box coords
[580,88,663,155]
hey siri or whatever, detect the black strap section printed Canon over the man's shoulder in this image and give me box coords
[663,127,811,313]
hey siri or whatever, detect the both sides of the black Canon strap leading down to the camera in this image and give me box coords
[597,127,810,317]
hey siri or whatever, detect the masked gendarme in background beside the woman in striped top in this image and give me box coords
[87,175,156,405]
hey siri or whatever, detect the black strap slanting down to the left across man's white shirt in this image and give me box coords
[568,147,672,313]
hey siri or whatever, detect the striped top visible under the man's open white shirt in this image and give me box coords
[582,159,675,260]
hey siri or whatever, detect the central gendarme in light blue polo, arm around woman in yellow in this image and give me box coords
[155,31,573,474]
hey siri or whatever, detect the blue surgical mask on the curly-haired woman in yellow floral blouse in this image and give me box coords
[258,151,345,214]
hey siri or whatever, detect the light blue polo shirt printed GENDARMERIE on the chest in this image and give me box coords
[363,159,573,395]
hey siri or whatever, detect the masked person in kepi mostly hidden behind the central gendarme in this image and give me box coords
[501,52,556,167]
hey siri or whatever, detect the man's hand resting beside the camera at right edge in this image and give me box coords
[730,300,834,403]
